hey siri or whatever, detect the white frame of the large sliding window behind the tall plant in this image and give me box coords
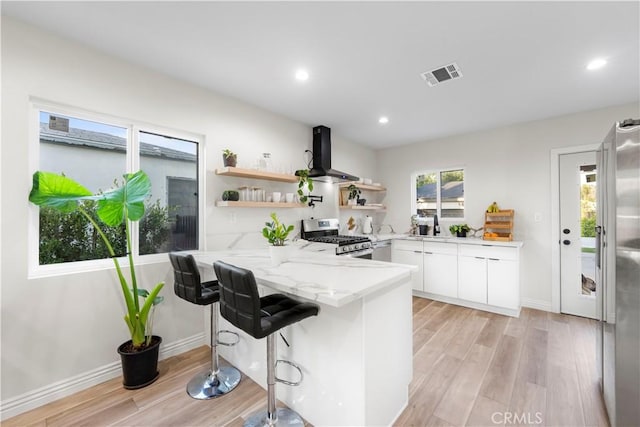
[27,98,206,279]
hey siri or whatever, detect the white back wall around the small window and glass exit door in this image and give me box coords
[377,104,640,309]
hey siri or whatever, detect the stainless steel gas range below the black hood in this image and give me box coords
[300,218,373,259]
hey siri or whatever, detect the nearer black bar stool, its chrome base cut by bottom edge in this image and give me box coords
[213,261,319,426]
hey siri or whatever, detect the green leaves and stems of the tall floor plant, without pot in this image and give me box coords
[29,171,164,349]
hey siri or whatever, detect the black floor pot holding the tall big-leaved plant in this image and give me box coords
[118,335,162,390]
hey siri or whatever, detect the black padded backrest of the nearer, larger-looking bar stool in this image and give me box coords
[213,261,262,337]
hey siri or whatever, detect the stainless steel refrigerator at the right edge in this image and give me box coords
[596,120,640,426]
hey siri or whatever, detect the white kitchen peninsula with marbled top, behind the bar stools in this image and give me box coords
[193,247,412,426]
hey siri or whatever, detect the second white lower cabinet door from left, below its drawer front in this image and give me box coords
[424,252,458,298]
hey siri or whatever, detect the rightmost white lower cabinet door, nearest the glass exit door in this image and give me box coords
[487,258,520,309]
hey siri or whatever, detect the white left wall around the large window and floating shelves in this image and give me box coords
[1,16,375,417]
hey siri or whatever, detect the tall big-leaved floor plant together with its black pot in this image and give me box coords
[29,171,164,389]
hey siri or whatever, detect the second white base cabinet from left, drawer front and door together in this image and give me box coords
[423,242,458,298]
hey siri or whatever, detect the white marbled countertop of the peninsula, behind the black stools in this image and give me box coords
[191,251,417,307]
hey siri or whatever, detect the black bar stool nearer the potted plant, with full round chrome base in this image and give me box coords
[169,252,241,399]
